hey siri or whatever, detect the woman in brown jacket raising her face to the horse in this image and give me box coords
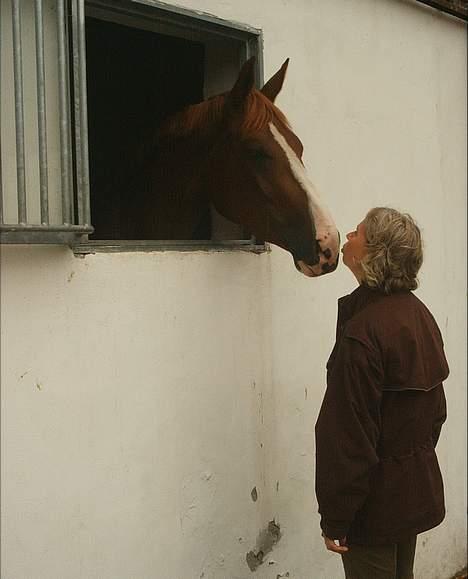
[315,207,449,579]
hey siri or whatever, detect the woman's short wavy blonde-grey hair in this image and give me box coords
[360,207,423,294]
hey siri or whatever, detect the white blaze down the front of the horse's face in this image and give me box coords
[269,123,339,261]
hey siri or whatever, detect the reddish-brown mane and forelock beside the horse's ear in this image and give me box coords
[159,90,289,139]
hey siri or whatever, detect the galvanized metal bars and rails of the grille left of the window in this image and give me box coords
[0,0,93,245]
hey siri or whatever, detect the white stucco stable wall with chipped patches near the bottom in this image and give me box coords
[1,0,466,579]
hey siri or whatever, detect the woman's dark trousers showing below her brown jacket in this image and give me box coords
[341,537,416,579]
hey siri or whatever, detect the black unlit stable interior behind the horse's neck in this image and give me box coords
[86,17,205,239]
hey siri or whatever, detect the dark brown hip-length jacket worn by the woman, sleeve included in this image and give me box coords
[315,286,449,544]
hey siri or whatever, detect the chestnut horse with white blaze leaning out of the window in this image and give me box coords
[120,58,340,277]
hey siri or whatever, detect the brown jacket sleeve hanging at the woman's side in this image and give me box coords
[315,337,383,539]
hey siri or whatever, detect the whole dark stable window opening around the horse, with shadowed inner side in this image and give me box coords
[86,2,258,244]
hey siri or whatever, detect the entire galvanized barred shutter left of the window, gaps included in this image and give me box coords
[0,0,93,244]
